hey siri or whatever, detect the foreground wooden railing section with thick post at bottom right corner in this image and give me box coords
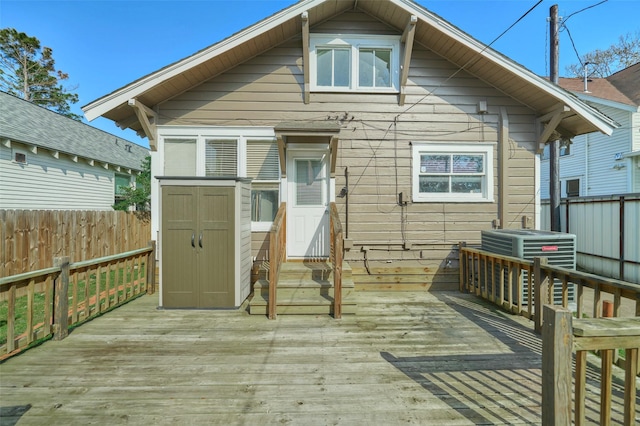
[542,305,640,425]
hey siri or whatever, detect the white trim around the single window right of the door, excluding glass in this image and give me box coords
[412,142,495,203]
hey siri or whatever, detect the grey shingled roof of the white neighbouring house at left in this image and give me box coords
[0,92,149,171]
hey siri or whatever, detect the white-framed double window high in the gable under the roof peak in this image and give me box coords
[309,34,400,93]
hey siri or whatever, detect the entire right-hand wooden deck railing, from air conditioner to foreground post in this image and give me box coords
[460,243,640,425]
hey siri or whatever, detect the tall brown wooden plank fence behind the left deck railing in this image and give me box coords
[0,210,151,277]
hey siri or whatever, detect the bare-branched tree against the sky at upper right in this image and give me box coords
[566,31,640,78]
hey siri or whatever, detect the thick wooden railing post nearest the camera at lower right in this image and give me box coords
[536,305,573,425]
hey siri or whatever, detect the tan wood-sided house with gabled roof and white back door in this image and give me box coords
[83,0,615,306]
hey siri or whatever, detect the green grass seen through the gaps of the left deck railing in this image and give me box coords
[0,263,146,345]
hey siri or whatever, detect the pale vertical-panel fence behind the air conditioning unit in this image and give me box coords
[541,194,640,284]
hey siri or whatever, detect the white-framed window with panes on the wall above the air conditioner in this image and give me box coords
[413,143,493,202]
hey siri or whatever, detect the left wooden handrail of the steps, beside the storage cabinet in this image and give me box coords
[267,203,287,319]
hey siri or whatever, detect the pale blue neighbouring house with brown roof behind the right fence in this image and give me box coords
[540,63,640,199]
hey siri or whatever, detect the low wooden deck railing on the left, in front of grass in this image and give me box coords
[0,241,155,359]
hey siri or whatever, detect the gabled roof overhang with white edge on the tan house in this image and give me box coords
[82,0,615,141]
